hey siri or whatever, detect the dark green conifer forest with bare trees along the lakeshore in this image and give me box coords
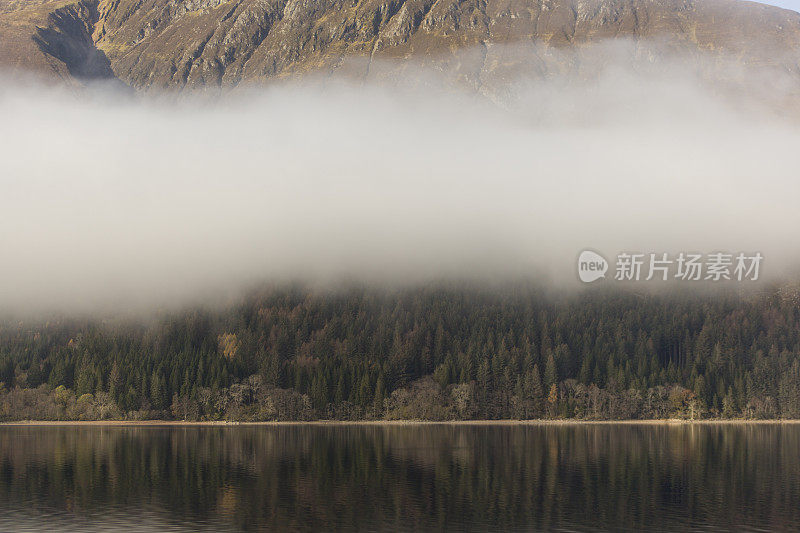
[0,284,800,422]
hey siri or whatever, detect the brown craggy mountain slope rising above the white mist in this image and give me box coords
[0,0,800,90]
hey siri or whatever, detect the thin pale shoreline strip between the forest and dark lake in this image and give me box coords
[0,419,800,427]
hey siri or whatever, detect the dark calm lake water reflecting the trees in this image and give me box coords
[0,424,800,531]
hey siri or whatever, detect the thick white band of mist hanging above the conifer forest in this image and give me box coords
[0,42,800,312]
